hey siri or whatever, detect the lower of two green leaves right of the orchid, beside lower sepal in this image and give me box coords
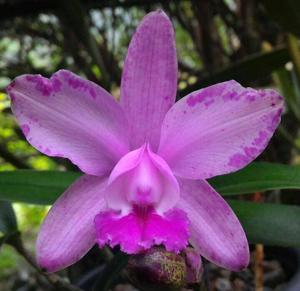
[229,200,300,247]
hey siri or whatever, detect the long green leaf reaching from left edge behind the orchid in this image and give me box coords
[0,170,80,205]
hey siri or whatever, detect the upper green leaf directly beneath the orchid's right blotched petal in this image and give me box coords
[209,162,300,196]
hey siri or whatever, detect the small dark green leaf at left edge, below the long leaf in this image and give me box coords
[0,201,18,237]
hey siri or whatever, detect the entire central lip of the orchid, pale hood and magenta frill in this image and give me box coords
[95,144,189,254]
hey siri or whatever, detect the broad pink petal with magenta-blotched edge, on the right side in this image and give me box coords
[158,81,283,179]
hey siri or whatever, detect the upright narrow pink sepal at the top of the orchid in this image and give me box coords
[121,11,177,150]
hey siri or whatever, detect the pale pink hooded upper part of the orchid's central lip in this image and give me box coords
[106,144,180,215]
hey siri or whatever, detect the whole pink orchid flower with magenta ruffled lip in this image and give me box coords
[8,11,283,272]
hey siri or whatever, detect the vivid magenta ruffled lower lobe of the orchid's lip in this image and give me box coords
[95,209,189,254]
